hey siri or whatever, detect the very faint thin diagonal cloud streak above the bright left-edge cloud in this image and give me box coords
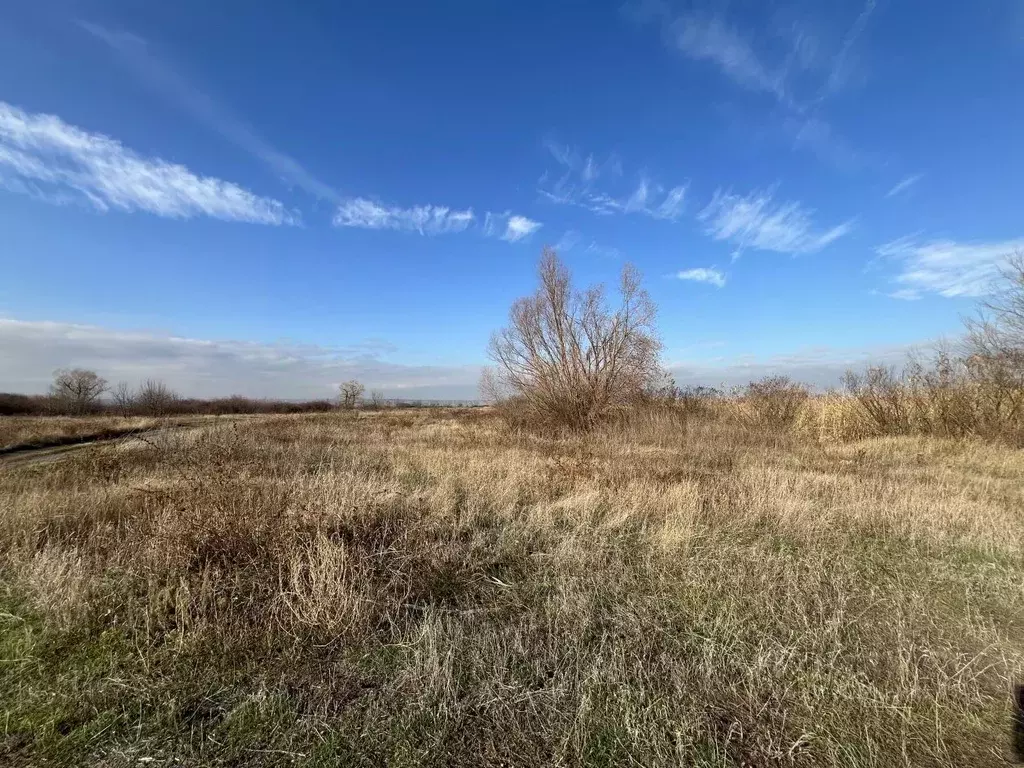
[80,22,341,203]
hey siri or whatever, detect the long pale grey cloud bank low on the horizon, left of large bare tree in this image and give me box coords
[0,318,480,399]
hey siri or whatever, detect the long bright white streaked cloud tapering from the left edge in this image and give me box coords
[0,101,299,224]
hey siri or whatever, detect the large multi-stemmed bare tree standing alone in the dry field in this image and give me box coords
[480,248,663,429]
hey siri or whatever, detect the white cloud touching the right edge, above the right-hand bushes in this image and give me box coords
[876,236,1024,299]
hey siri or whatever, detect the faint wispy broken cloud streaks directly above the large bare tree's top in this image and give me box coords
[538,139,688,221]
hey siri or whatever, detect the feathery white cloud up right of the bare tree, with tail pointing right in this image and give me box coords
[698,189,853,254]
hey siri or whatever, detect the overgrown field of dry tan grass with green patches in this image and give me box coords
[0,409,1024,767]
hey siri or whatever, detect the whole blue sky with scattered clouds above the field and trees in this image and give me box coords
[0,0,1024,396]
